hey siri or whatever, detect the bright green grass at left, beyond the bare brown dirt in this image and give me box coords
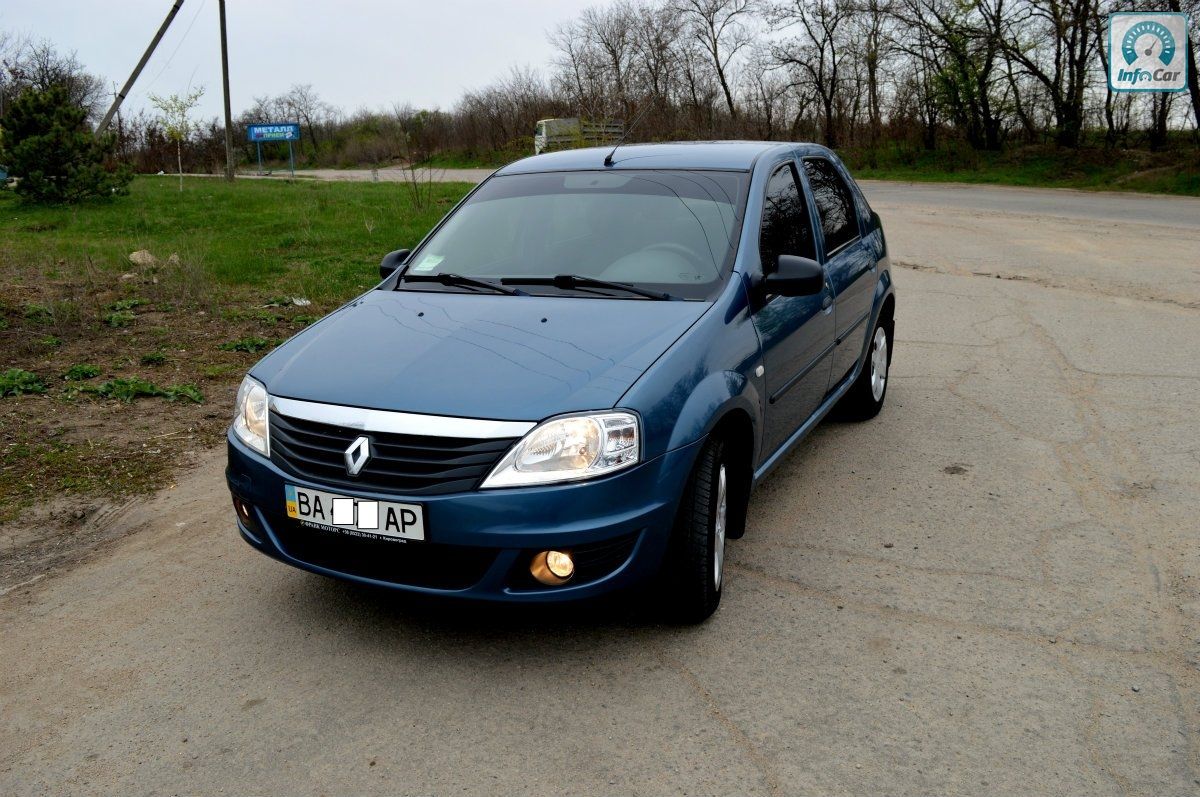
[0,176,469,303]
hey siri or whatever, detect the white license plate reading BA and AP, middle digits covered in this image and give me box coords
[283,485,425,540]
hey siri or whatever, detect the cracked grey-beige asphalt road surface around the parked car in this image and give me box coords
[0,184,1200,797]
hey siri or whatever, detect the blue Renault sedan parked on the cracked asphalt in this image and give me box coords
[227,142,895,622]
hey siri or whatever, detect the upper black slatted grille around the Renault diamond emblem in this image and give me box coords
[270,413,517,496]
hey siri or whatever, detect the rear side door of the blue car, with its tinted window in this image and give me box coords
[803,156,877,388]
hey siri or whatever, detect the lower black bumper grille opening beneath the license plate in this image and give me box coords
[270,514,497,589]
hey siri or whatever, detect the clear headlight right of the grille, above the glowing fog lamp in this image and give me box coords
[482,412,642,489]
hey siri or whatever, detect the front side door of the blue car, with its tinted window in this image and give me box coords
[754,160,834,455]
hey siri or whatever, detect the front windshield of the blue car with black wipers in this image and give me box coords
[397,169,749,299]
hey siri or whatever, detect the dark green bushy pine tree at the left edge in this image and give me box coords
[0,86,133,204]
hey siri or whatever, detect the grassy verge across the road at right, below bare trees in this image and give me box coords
[841,146,1200,197]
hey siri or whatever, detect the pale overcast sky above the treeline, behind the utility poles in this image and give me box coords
[0,0,599,116]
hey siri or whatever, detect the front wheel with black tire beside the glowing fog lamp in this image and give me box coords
[662,438,730,624]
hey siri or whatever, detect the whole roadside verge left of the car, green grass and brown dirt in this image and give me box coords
[0,176,468,522]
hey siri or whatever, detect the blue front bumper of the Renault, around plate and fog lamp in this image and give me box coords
[226,435,700,603]
